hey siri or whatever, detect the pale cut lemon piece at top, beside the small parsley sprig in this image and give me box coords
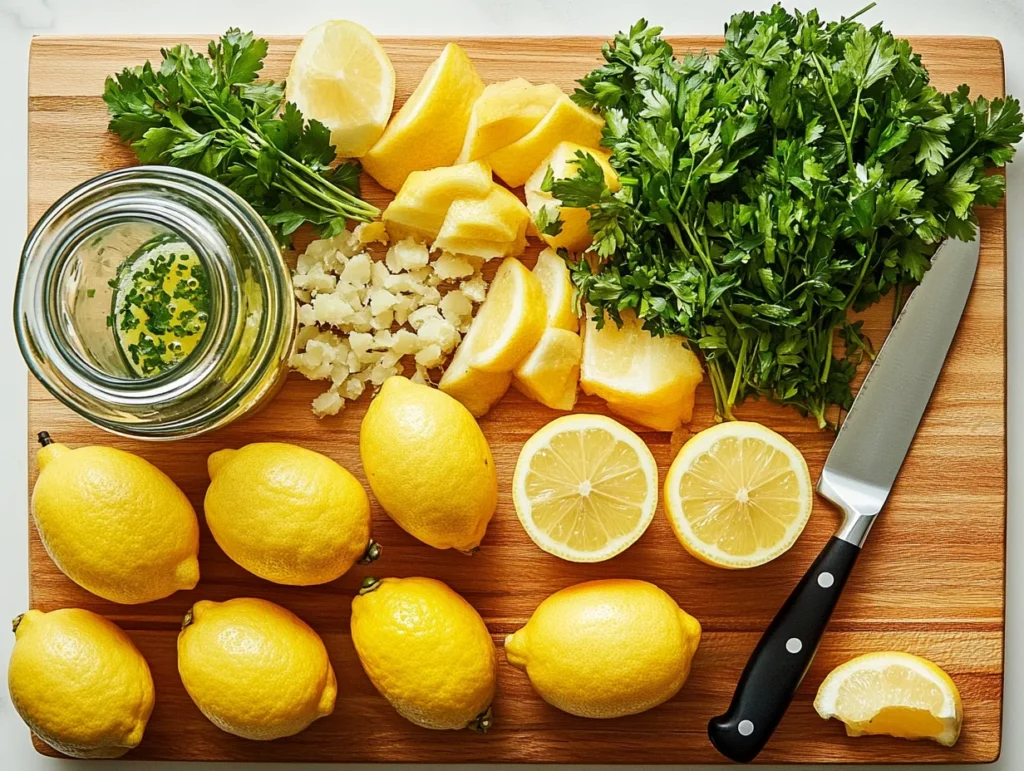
[288,22,394,158]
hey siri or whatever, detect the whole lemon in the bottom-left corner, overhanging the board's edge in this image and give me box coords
[7,608,154,758]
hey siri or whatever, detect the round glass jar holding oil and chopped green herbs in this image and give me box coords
[14,166,296,439]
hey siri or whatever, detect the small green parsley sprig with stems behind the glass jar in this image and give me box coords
[103,29,380,244]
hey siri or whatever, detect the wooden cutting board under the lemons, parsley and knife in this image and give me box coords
[28,31,1007,764]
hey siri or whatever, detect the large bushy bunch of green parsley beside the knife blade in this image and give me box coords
[565,5,1024,427]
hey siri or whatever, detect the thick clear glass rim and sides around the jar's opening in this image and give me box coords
[14,166,295,438]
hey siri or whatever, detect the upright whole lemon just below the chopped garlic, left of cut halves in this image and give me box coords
[359,377,498,552]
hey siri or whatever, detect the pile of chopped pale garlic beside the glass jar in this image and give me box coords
[290,222,486,417]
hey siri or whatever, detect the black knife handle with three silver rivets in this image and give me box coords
[708,537,860,763]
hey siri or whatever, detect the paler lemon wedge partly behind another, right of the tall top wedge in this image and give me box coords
[459,78,562,163]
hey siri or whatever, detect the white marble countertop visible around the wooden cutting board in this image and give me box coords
[0,0,1024,771]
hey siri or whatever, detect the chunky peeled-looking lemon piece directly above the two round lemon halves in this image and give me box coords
[580,308,703,431]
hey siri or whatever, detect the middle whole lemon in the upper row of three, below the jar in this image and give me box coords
[204,442,380,587]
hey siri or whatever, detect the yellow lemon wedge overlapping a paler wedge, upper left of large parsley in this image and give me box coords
[483,94,604,187]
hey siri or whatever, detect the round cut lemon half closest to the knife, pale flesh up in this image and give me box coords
[665,421,811,568]
